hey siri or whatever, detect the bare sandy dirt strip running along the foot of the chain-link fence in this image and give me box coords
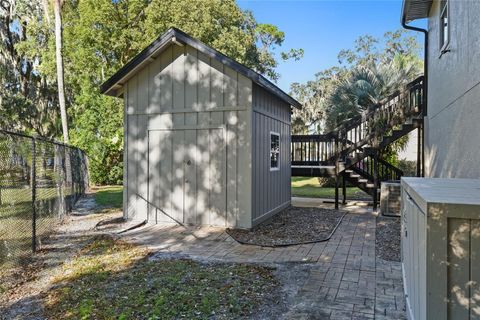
[0,196,128,320]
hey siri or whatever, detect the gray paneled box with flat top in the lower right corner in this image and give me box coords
[401,178,480,320]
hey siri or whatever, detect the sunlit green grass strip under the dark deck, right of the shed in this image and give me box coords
[292,177,370,199]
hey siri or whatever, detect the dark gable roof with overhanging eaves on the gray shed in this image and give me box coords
[100,28,302,108]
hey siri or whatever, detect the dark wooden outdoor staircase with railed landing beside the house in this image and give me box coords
[291,77,424,208]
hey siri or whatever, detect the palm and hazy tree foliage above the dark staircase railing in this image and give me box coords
[291,30,422,133]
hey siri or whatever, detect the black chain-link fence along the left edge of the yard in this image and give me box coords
[0,130,88,265]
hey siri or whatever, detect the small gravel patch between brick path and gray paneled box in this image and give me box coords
[375,215,400,261]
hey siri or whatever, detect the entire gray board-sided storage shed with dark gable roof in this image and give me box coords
[101,28,301,228]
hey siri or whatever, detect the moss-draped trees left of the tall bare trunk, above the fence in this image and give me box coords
[0,0,59,137]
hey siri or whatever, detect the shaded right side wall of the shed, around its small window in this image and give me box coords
[252,85,291,222]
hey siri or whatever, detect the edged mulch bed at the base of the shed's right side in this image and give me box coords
[227,207,345,247]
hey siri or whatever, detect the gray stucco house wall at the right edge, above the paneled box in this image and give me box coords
[425,0,480,178]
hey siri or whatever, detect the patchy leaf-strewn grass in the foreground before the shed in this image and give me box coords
[44,236,278,319]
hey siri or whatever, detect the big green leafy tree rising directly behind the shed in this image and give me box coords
[15,0,303,184]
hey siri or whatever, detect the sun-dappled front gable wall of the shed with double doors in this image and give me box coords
[125,45,252,228]
